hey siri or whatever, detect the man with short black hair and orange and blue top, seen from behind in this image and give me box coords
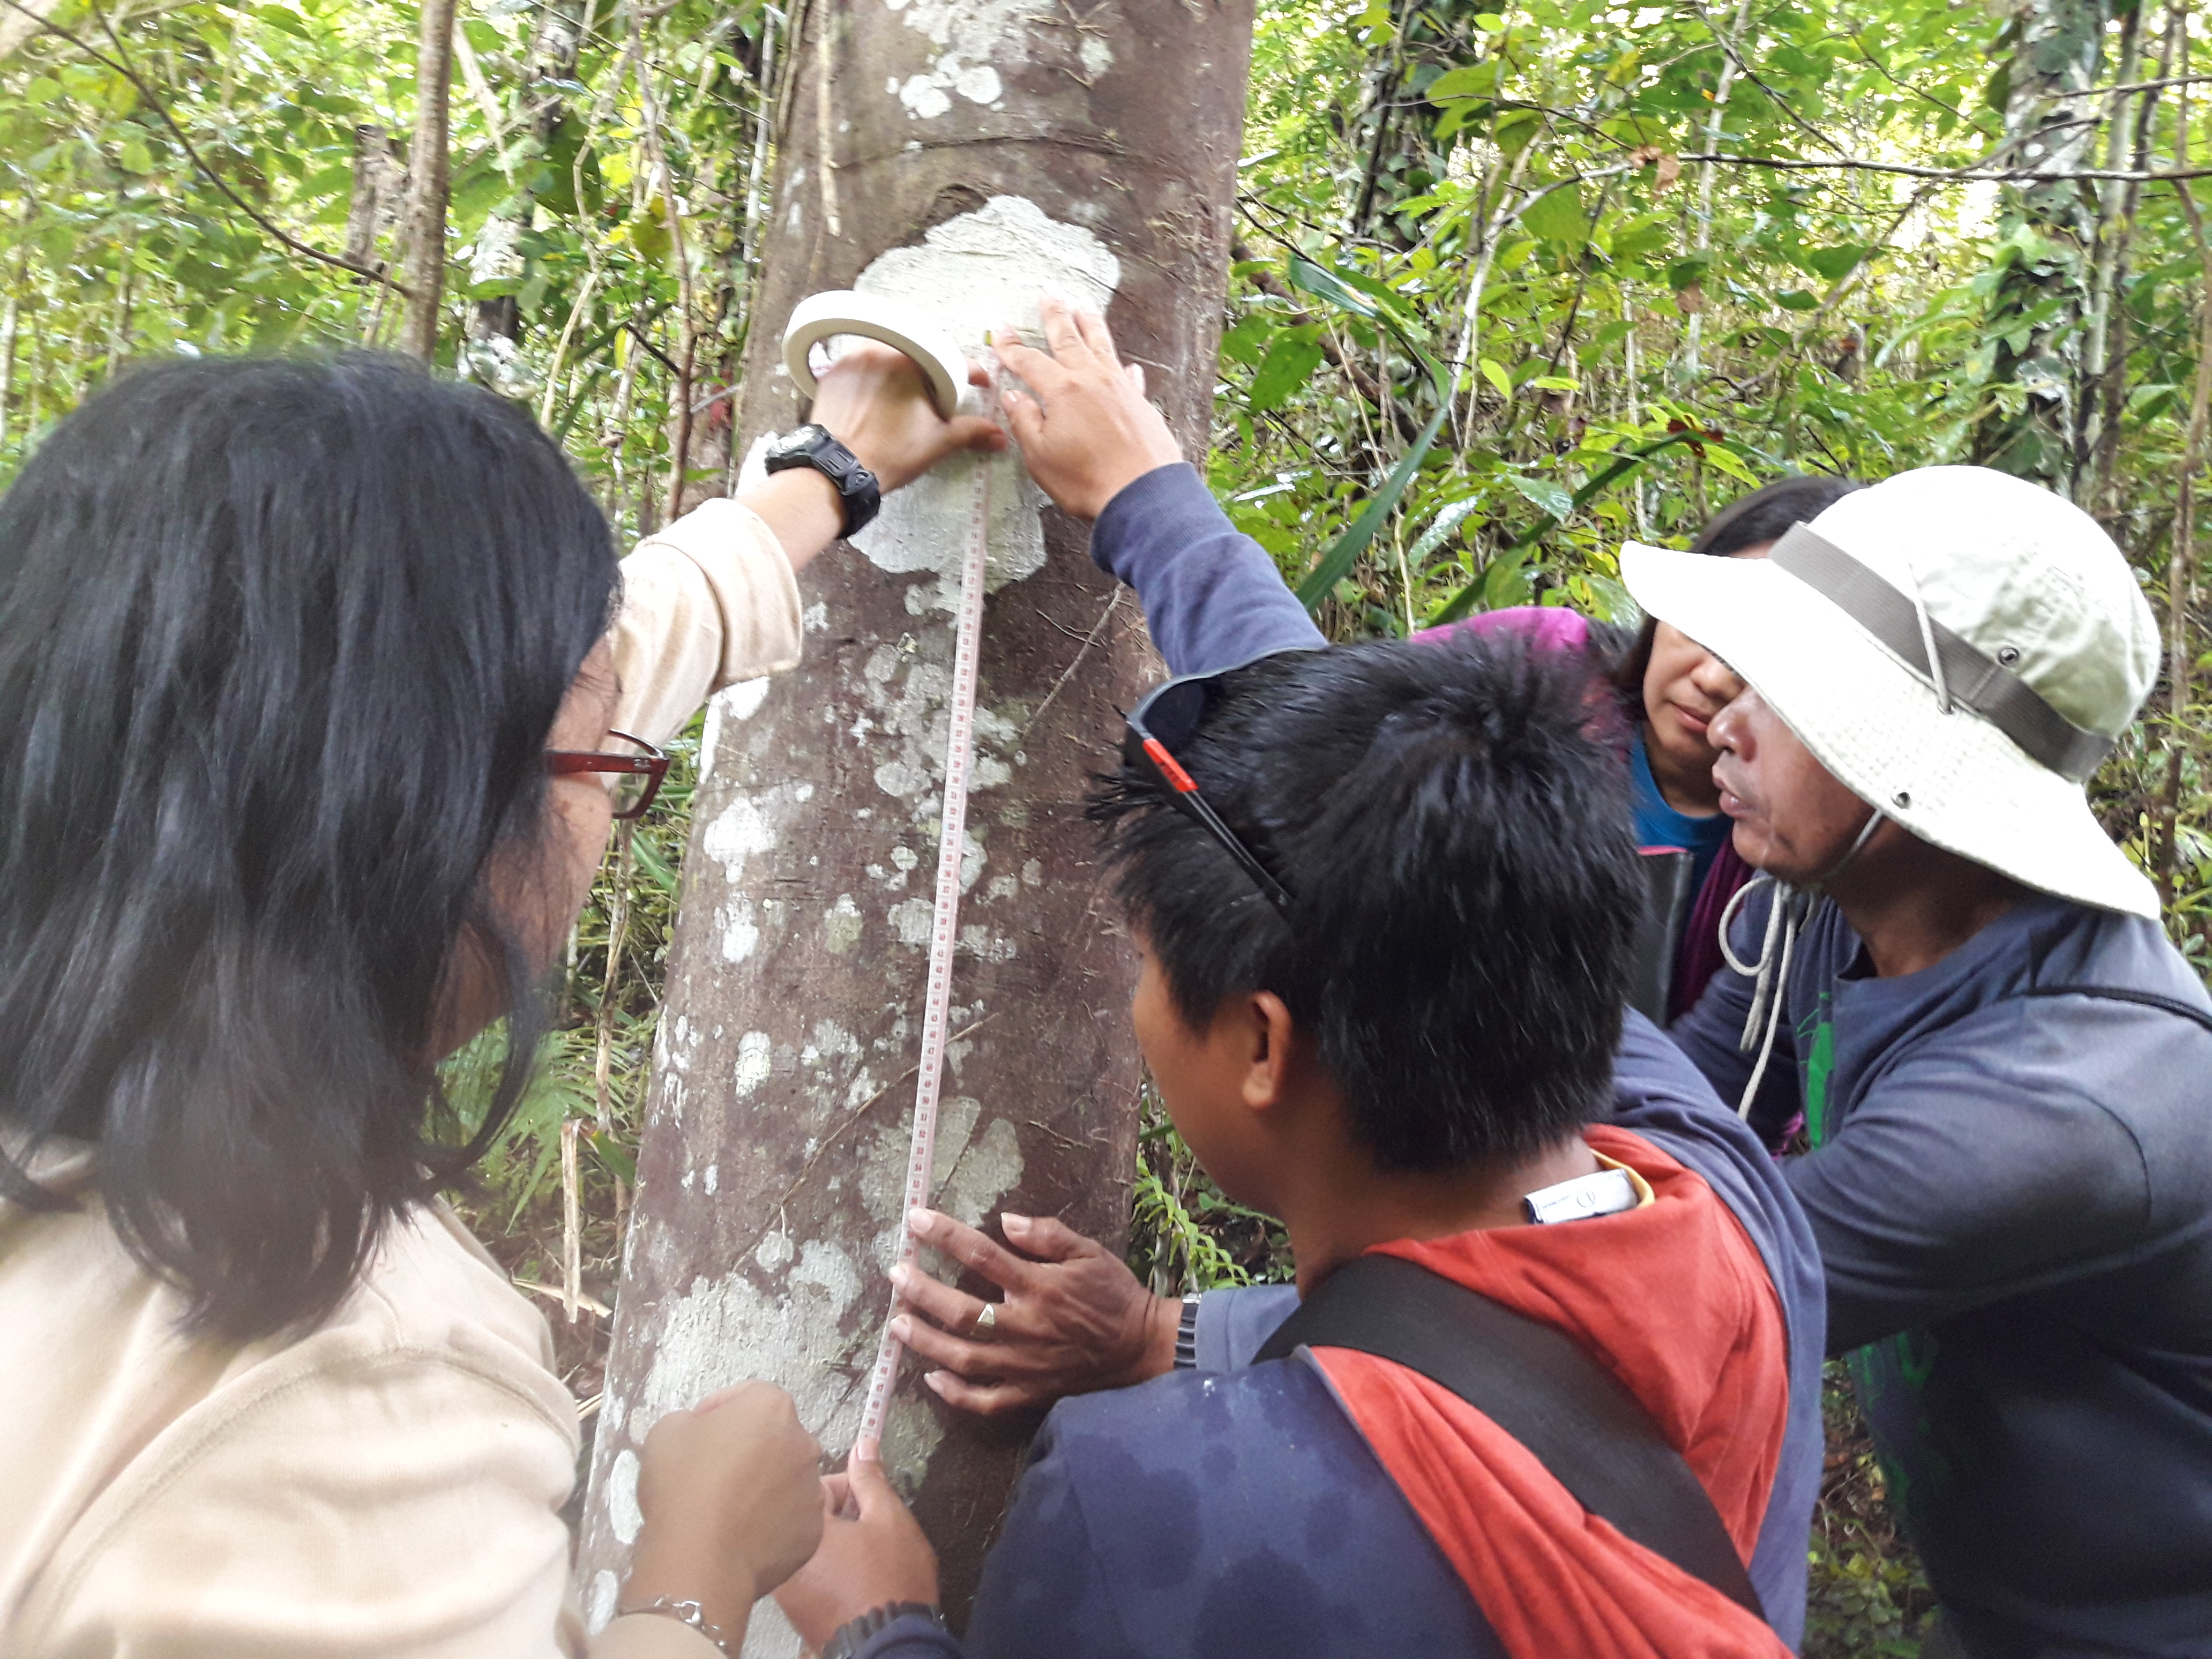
[779,639,1822,1659]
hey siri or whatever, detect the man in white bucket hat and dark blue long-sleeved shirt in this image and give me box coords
[1621,467,2212,1655]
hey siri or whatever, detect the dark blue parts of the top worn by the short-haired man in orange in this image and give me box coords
[867,1015,1822,1659]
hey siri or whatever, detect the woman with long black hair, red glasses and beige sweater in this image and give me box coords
[0,347,1004,1659]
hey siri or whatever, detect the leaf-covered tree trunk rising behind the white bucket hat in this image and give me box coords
[1973,0,2106,500]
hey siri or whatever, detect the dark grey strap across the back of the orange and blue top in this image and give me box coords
[1254,1257,1765,1619]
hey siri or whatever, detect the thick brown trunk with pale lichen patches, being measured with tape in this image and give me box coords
[577,0,1252,1655]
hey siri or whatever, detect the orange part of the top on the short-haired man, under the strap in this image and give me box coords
[1314,1126,1790,1659]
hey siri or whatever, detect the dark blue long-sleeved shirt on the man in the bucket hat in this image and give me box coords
[1672,889,2212,1657]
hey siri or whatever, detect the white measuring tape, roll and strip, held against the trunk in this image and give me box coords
[783,294,991,1460]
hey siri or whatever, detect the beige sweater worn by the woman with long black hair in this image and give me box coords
[0,502,801,1659]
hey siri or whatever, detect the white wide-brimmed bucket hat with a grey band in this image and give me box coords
[1621,467,2159,920]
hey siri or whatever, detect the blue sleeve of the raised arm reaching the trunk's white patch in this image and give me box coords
[1090,460,1329,675]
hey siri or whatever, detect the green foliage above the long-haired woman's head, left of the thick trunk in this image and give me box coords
[0,0,767,542]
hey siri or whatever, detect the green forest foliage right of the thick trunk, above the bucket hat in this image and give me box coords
[1210,0,2212,924]
